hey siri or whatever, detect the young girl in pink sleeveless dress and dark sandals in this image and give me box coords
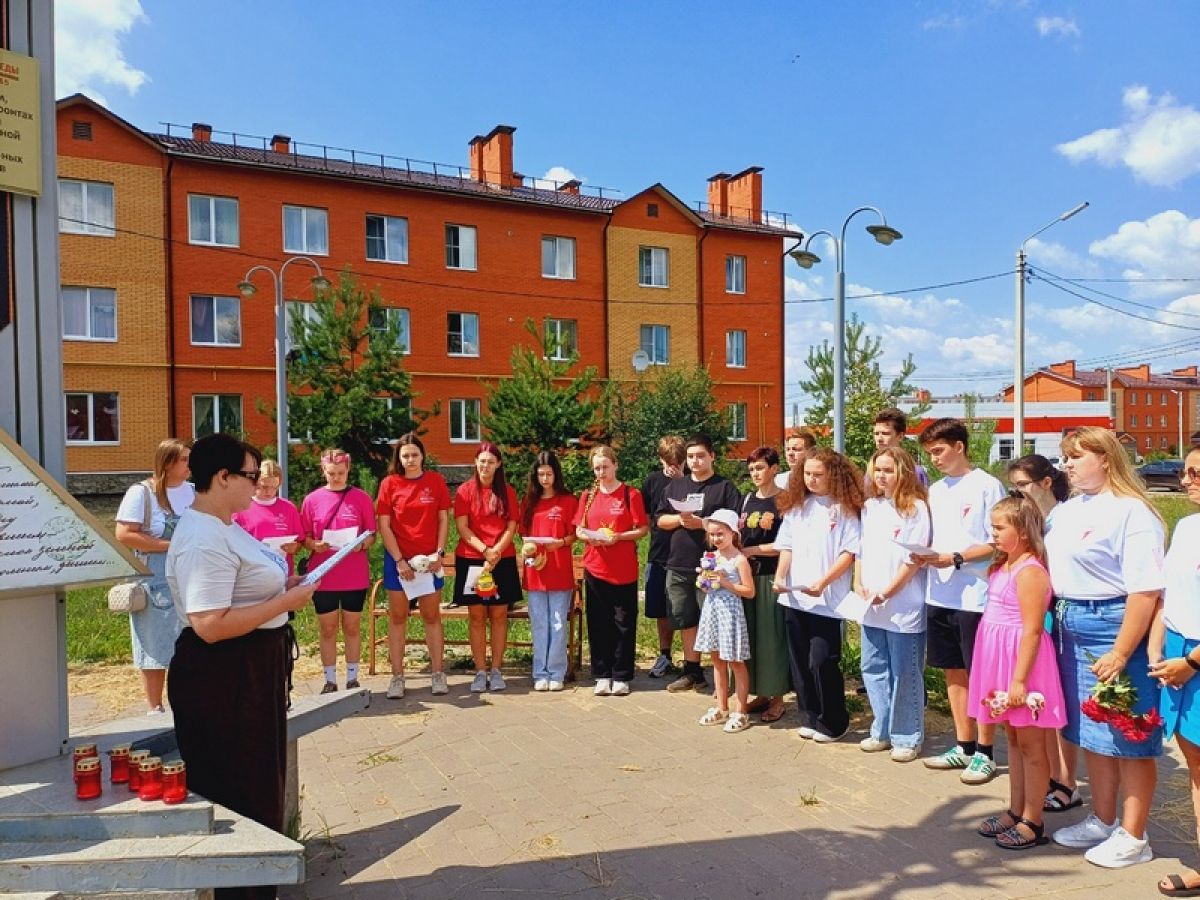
[967,497,1067,850]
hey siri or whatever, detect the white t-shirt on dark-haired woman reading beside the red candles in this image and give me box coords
[167,509,288,628]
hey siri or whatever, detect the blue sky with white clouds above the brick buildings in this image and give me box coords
[56,0,1200,417]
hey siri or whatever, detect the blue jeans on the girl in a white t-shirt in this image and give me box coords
[862,626,925,748]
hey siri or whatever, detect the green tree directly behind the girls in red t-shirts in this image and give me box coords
[480,319,600,490]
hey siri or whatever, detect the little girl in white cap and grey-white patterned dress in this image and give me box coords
[695,509,755,733]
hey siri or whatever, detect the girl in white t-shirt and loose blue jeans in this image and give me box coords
[856,448,932,762]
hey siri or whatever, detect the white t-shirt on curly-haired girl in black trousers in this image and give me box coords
[775,494,862,619]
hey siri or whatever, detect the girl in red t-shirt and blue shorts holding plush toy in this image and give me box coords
[376,432,450,700]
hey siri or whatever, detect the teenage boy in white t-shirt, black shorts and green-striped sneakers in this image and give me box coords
[917,419,1004,785]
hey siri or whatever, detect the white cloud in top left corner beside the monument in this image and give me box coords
[54,0,150,103]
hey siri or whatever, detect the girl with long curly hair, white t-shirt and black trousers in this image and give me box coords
[775,448,863,744]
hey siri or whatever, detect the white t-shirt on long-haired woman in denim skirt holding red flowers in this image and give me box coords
[1046,491,1165,600]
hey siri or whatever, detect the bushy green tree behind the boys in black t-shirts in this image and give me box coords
[606,366,730,485]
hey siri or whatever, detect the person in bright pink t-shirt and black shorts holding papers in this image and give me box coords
[300,450,376,694]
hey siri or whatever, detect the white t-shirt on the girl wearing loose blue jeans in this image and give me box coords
[858,497,932,635]
